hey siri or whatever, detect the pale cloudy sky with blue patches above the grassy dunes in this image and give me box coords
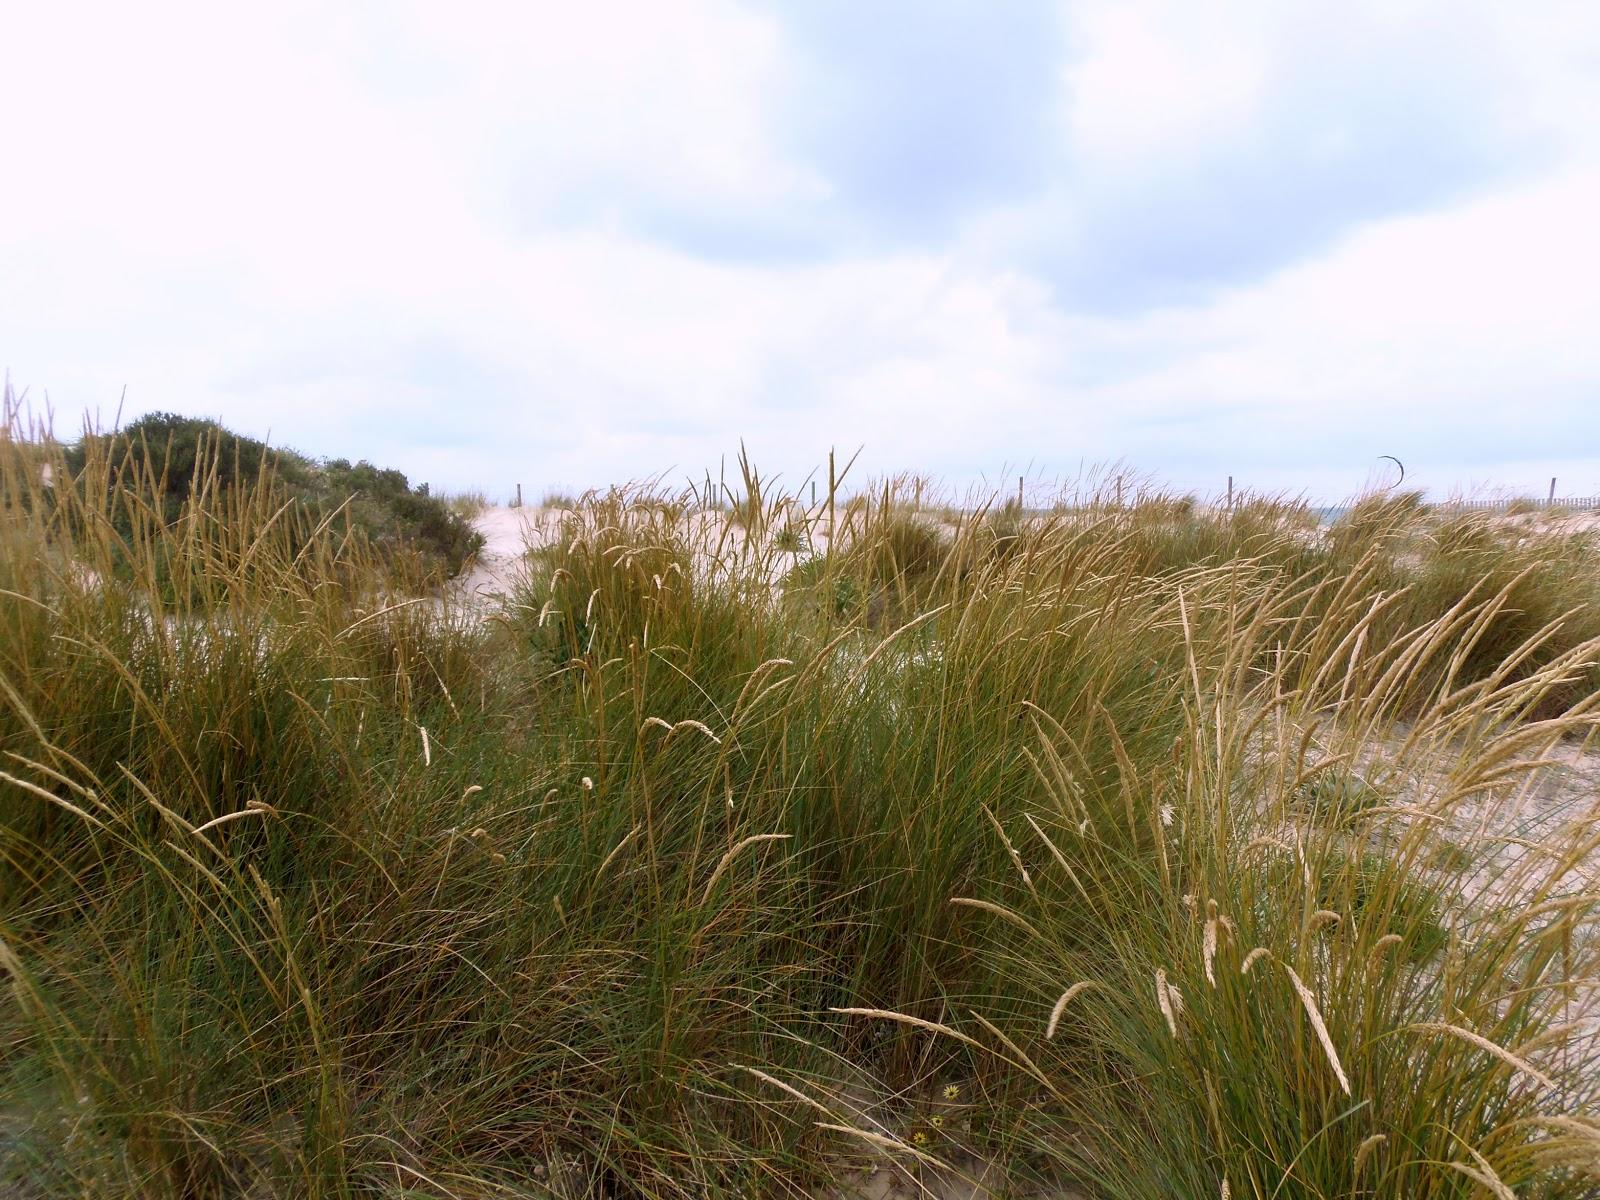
[0,0,1600,502]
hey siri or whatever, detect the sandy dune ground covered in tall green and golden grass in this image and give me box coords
[0,413,1600,1200]
